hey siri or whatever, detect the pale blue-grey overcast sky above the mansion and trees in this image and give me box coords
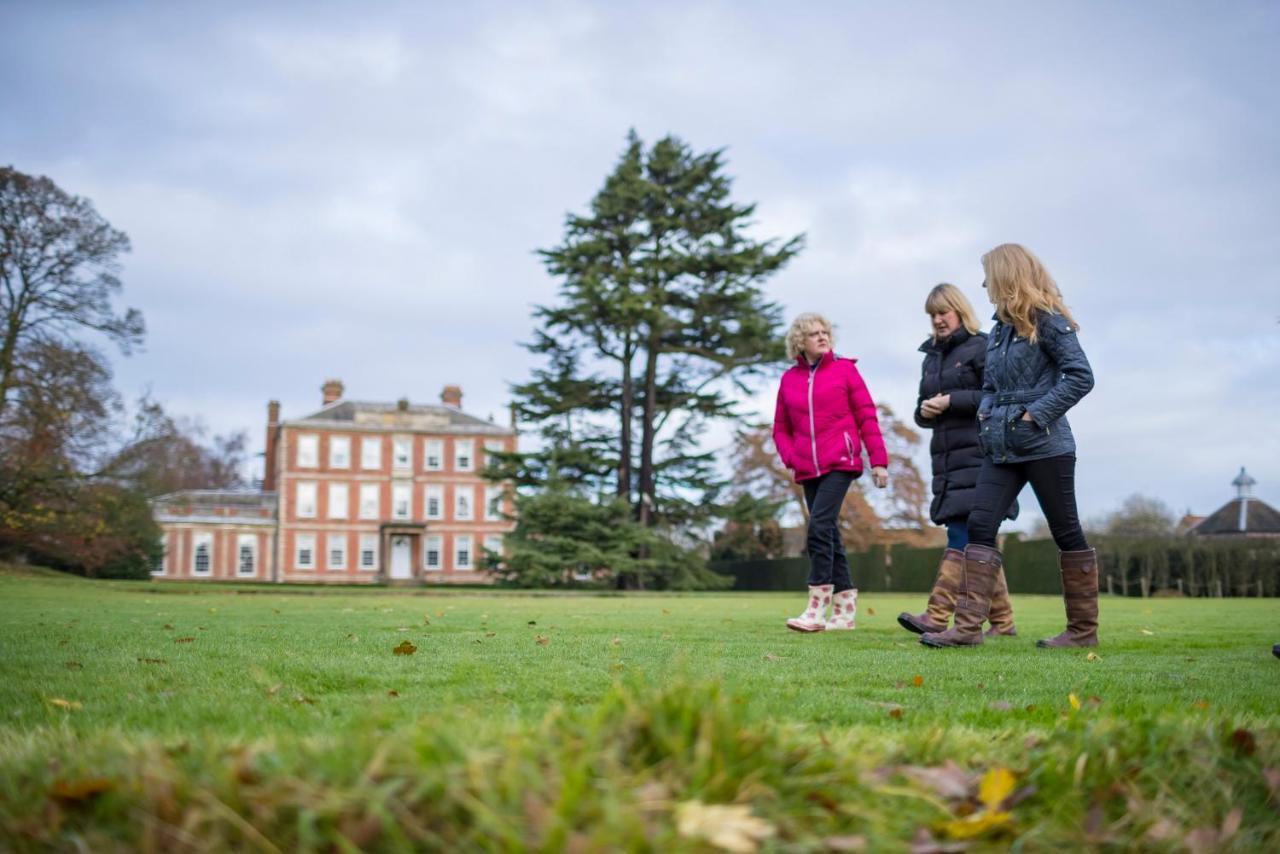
[0,0,1280,535]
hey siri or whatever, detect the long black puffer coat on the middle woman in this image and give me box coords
[915,326,1018,525]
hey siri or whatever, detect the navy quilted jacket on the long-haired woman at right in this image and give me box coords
[978,314,1093,462]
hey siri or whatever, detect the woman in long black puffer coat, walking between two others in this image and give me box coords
[897,284,1018,636]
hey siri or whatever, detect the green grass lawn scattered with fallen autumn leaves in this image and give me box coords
[0,570,1280,850]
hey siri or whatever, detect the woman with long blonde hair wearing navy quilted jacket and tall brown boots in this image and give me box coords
[920,243,1098,647]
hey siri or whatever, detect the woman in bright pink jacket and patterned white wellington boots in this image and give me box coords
[773,314,888,631]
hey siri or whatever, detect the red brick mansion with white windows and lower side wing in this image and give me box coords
[152,380,516,583]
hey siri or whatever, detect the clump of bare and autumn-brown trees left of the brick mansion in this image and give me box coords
[0,166,247,577]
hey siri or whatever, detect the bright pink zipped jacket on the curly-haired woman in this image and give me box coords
[773,352,888,481]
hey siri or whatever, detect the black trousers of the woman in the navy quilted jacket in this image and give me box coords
[969,455,1089,552]
